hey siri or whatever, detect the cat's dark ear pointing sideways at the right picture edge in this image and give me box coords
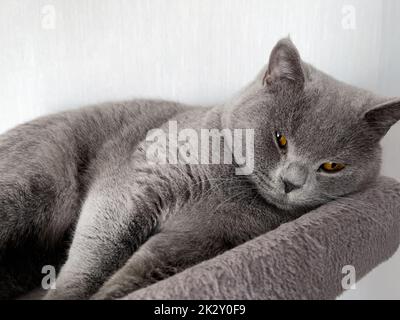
[364,98,400,138]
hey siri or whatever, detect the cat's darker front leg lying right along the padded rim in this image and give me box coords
[91,230,220,300]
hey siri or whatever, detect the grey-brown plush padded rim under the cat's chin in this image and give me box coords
[125,178,400,299]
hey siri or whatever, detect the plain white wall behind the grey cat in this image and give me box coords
[0,0,400,298]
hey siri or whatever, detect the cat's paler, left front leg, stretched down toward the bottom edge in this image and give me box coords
[45,180,157,299]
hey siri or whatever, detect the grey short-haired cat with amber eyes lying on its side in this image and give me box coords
[0,38,400,299]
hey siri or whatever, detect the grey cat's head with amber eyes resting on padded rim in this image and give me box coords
[225,39,400,210]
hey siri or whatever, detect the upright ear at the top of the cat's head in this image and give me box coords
[263,38,305,89]
